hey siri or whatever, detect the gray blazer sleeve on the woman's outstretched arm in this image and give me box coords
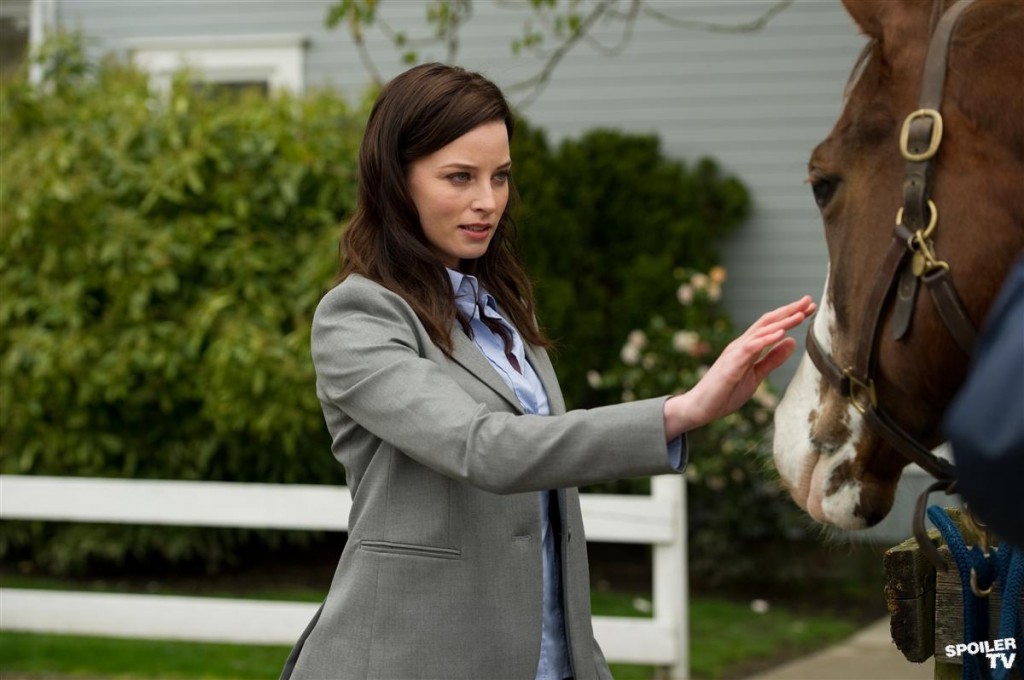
[311,280,677,494]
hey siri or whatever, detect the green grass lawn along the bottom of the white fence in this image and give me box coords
[0,577,856,680]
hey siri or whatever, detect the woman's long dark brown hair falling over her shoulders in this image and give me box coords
[338,63,551,353]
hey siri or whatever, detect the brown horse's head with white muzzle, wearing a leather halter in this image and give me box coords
[774,0,1024,528]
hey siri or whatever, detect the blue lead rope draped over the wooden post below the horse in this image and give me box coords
[928,505,1024,680]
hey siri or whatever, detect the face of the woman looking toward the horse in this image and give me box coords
[408,121,512,269]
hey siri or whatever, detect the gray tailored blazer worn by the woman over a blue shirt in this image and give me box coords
[282,275,675,680]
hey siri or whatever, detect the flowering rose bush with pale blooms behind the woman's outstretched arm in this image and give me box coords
[589,266,807,588]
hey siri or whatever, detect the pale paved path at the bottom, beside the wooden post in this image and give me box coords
[748,617,935,680]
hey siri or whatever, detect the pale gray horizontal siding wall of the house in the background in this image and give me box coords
[51,0,864,386]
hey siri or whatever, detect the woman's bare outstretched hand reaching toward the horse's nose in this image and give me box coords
[665,295,816,440]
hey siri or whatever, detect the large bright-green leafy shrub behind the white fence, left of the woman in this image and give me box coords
[0,33,362,570]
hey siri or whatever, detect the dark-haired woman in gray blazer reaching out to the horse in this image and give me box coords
[282,65,814,680]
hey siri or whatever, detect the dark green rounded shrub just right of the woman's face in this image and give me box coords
[512,126,749,408]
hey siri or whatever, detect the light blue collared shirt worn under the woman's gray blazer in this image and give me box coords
[447,269,685,680]
